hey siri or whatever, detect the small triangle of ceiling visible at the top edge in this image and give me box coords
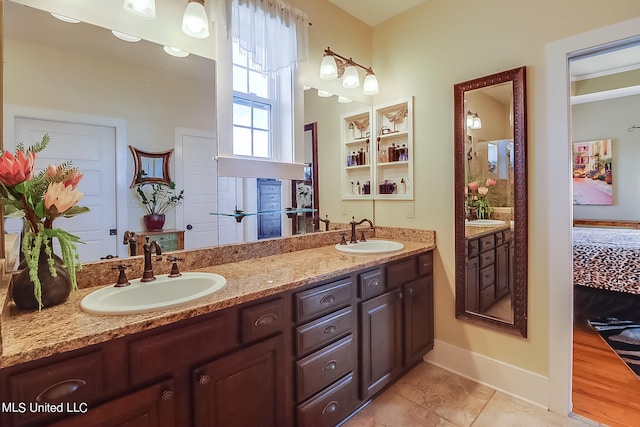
[329,0,427,27]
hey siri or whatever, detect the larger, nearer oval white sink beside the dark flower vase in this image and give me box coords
[80,272,227,315]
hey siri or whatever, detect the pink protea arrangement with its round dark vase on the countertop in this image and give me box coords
[0,134,89,310]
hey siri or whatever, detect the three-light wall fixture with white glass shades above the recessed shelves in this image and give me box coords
[320,48,379,95]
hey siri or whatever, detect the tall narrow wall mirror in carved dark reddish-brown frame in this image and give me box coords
[454,67,528,337]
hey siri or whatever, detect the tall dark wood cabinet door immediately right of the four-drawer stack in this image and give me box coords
[360,289,402,400]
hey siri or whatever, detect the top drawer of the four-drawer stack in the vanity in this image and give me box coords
[295,278,353,321]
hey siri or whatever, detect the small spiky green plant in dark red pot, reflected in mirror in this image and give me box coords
[136,181,184,231]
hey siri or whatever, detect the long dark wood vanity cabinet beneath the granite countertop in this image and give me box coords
[0,252,436,427]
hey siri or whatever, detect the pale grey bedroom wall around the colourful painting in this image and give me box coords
[571,95,640,221]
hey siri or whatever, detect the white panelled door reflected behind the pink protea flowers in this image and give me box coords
[12,117,117,262]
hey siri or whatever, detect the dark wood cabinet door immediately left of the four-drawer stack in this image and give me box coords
[193,335,287,427]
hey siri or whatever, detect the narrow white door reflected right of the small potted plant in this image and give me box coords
[176,129,218,249]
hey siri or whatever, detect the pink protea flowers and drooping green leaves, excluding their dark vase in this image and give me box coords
[0,134,89,309]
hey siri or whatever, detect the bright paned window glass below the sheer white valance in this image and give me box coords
[233,38,277,158]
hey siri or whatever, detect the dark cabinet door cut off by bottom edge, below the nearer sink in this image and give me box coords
[50,381,178,427]
